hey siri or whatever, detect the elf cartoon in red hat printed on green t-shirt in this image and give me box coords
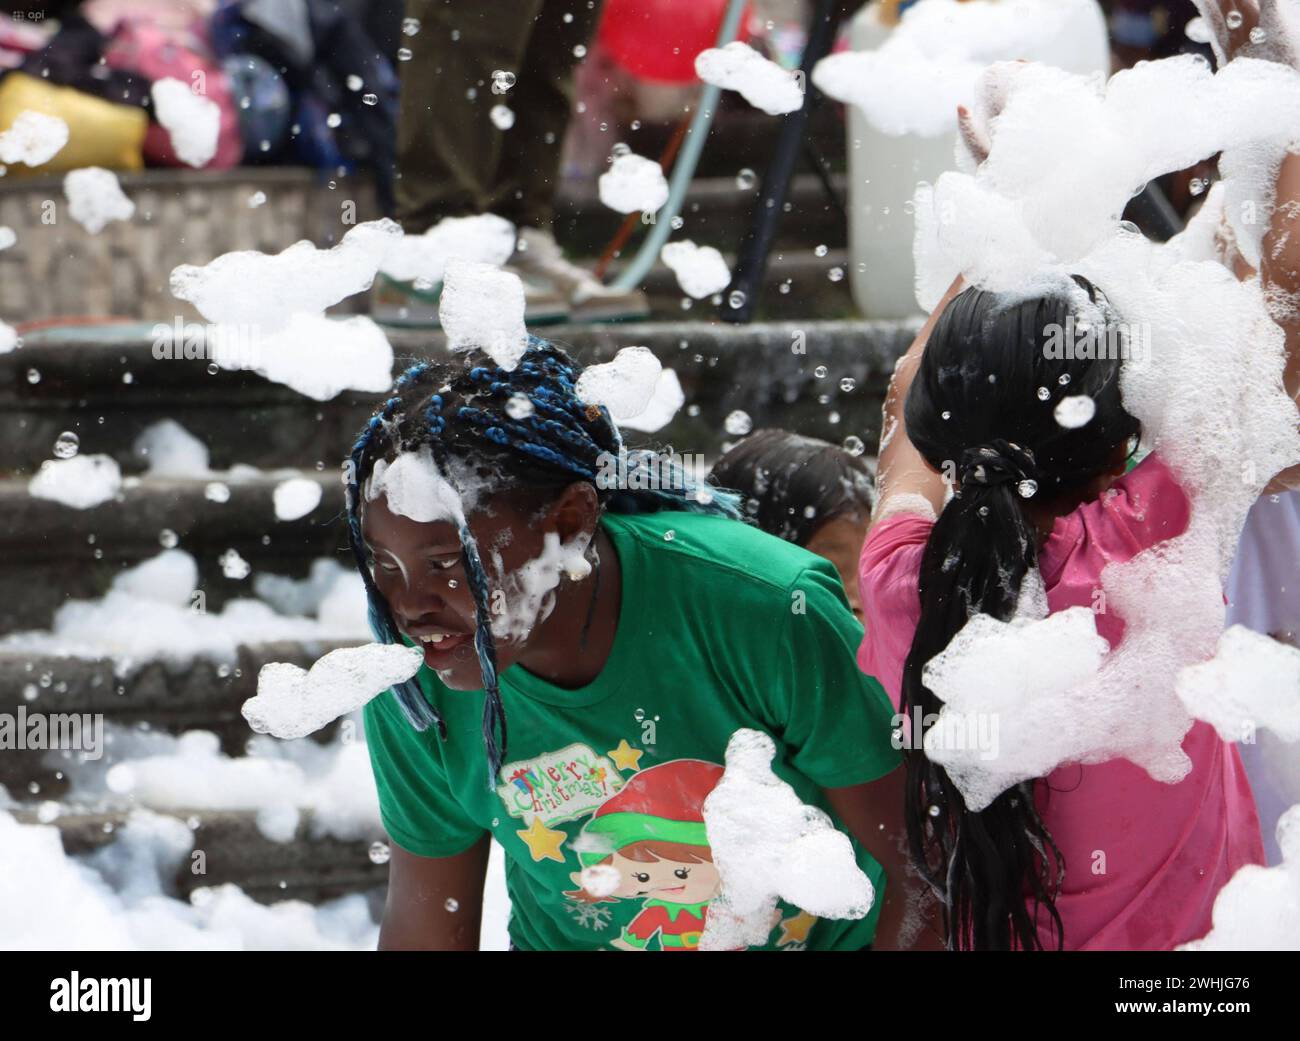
[566,759,723,950]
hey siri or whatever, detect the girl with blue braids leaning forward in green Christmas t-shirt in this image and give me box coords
[346,339,920,950]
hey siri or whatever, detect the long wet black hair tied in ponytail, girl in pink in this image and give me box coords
[900,277,1139,950]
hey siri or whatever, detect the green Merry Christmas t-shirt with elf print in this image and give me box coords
[365,512,900,950]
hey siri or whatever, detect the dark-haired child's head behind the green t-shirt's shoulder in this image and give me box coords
[709,430,876,617]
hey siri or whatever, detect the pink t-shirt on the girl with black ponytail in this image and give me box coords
[858,456,1264,950]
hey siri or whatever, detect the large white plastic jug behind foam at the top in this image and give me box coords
[848,0,1110,318]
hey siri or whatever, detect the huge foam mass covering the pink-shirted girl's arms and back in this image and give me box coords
[894,42,1300,798]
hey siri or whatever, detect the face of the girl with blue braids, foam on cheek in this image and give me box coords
[361,485,595,690]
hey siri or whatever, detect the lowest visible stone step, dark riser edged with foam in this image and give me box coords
[14,807,389,904]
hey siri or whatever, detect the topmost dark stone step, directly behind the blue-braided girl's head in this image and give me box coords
[0,317,919,478]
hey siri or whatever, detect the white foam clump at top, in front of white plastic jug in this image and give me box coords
[813,0,1109,136]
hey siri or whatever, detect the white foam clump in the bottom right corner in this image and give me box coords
[1179,806,1300,950]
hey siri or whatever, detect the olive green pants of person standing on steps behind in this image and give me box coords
[397,0,601,233]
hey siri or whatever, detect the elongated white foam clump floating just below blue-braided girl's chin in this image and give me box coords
[239,643,424,741]
